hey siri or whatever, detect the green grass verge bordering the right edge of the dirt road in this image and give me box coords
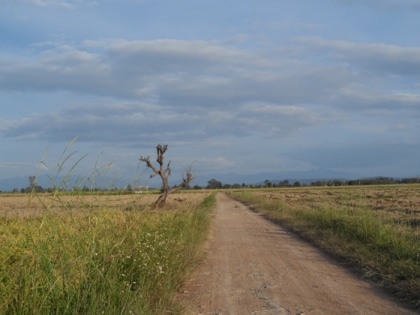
[232,188,420,306]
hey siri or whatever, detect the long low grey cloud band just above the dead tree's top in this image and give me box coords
[1,103,327,145]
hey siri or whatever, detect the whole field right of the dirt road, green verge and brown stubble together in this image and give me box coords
[229,185,420,307]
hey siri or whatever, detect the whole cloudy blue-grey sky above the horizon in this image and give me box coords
[0,0,420,188]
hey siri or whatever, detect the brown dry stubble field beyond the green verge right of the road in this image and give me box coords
[246,185,420,235]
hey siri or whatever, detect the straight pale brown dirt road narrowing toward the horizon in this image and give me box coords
[181,193,416,315]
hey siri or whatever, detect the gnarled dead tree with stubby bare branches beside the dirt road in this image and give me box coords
[139,144,193,208]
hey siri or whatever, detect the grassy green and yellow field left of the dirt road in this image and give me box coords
[0,192,215,314]
